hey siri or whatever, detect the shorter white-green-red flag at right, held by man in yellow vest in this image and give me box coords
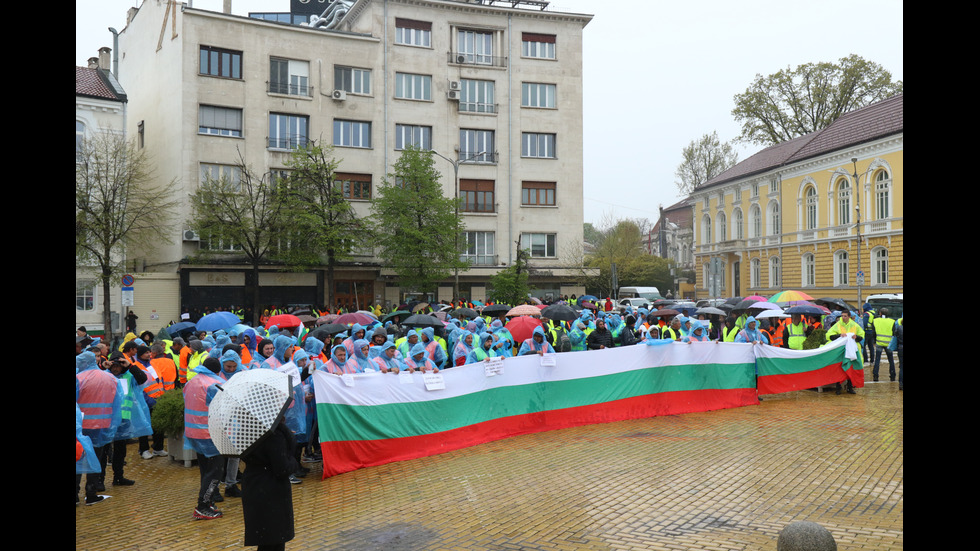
[756,338,864,394]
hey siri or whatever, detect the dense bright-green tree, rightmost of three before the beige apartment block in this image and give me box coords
[371,147,468,298]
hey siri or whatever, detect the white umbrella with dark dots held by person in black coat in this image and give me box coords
[208,369,293,456]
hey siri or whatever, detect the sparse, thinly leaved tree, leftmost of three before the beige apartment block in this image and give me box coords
[191,152,292,324]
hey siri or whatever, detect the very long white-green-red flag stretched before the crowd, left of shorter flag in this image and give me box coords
[313,341,759,478]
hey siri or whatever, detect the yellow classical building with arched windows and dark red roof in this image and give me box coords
[692,95,904,306]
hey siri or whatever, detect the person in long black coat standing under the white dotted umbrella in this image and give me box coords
[242,421,299,551]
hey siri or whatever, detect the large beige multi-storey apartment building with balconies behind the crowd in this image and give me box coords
[119,0,591,314]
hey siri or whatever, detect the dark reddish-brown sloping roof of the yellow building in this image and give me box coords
[695,94,905,191]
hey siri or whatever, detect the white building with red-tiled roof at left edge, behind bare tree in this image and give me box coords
[75,47,127,335]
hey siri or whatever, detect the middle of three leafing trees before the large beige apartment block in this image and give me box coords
[282,141,370,306]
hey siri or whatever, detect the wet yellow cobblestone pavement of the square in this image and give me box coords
[75,369,904,551]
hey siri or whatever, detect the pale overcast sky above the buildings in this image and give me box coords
[75,0,904,226]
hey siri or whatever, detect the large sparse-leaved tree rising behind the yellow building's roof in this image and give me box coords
[732,54,903,146]
